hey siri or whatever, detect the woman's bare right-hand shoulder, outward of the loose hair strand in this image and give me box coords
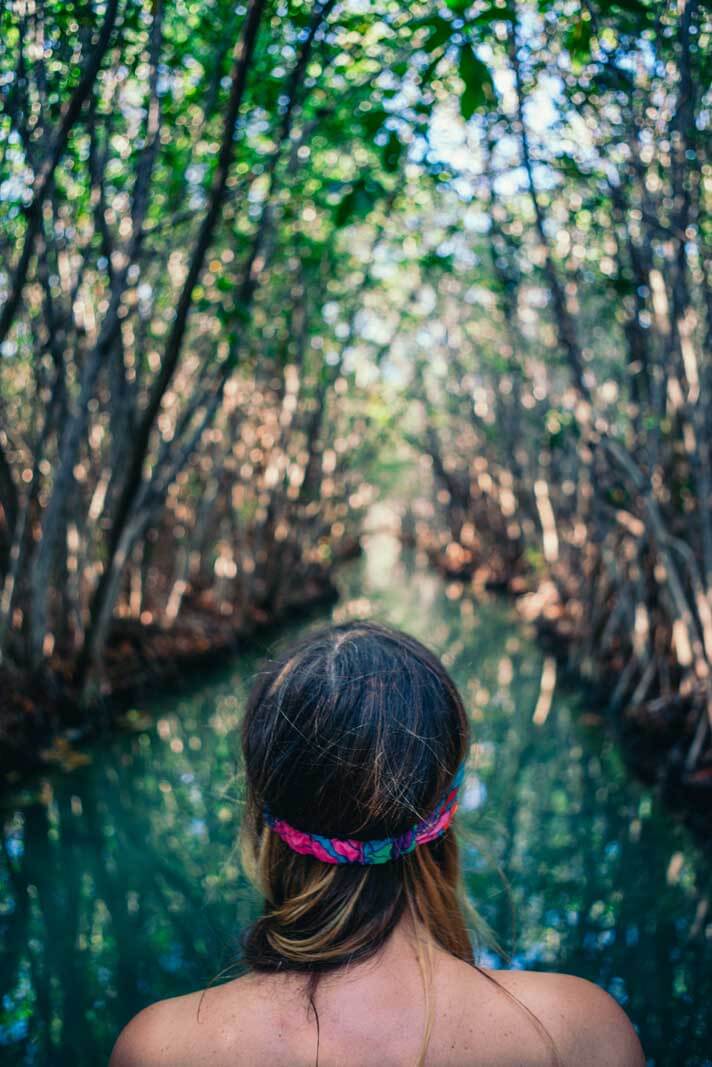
[486,971,645,1067]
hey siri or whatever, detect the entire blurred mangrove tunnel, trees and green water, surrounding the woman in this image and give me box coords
[0,0,712,1067]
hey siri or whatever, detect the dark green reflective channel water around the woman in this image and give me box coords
[0,538,712,1067]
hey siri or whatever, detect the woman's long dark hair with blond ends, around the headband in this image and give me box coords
[242,621,472,973]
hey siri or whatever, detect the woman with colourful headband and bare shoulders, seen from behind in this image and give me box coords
[110,621,645,1067]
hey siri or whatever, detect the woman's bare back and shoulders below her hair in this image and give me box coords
[110,917,645,1067]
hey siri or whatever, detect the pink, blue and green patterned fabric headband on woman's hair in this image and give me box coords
[264,762,464,864]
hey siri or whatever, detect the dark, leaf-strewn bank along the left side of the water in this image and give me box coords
[0,567,345,786]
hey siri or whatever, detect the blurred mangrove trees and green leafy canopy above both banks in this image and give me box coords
[0,0,712,774]
